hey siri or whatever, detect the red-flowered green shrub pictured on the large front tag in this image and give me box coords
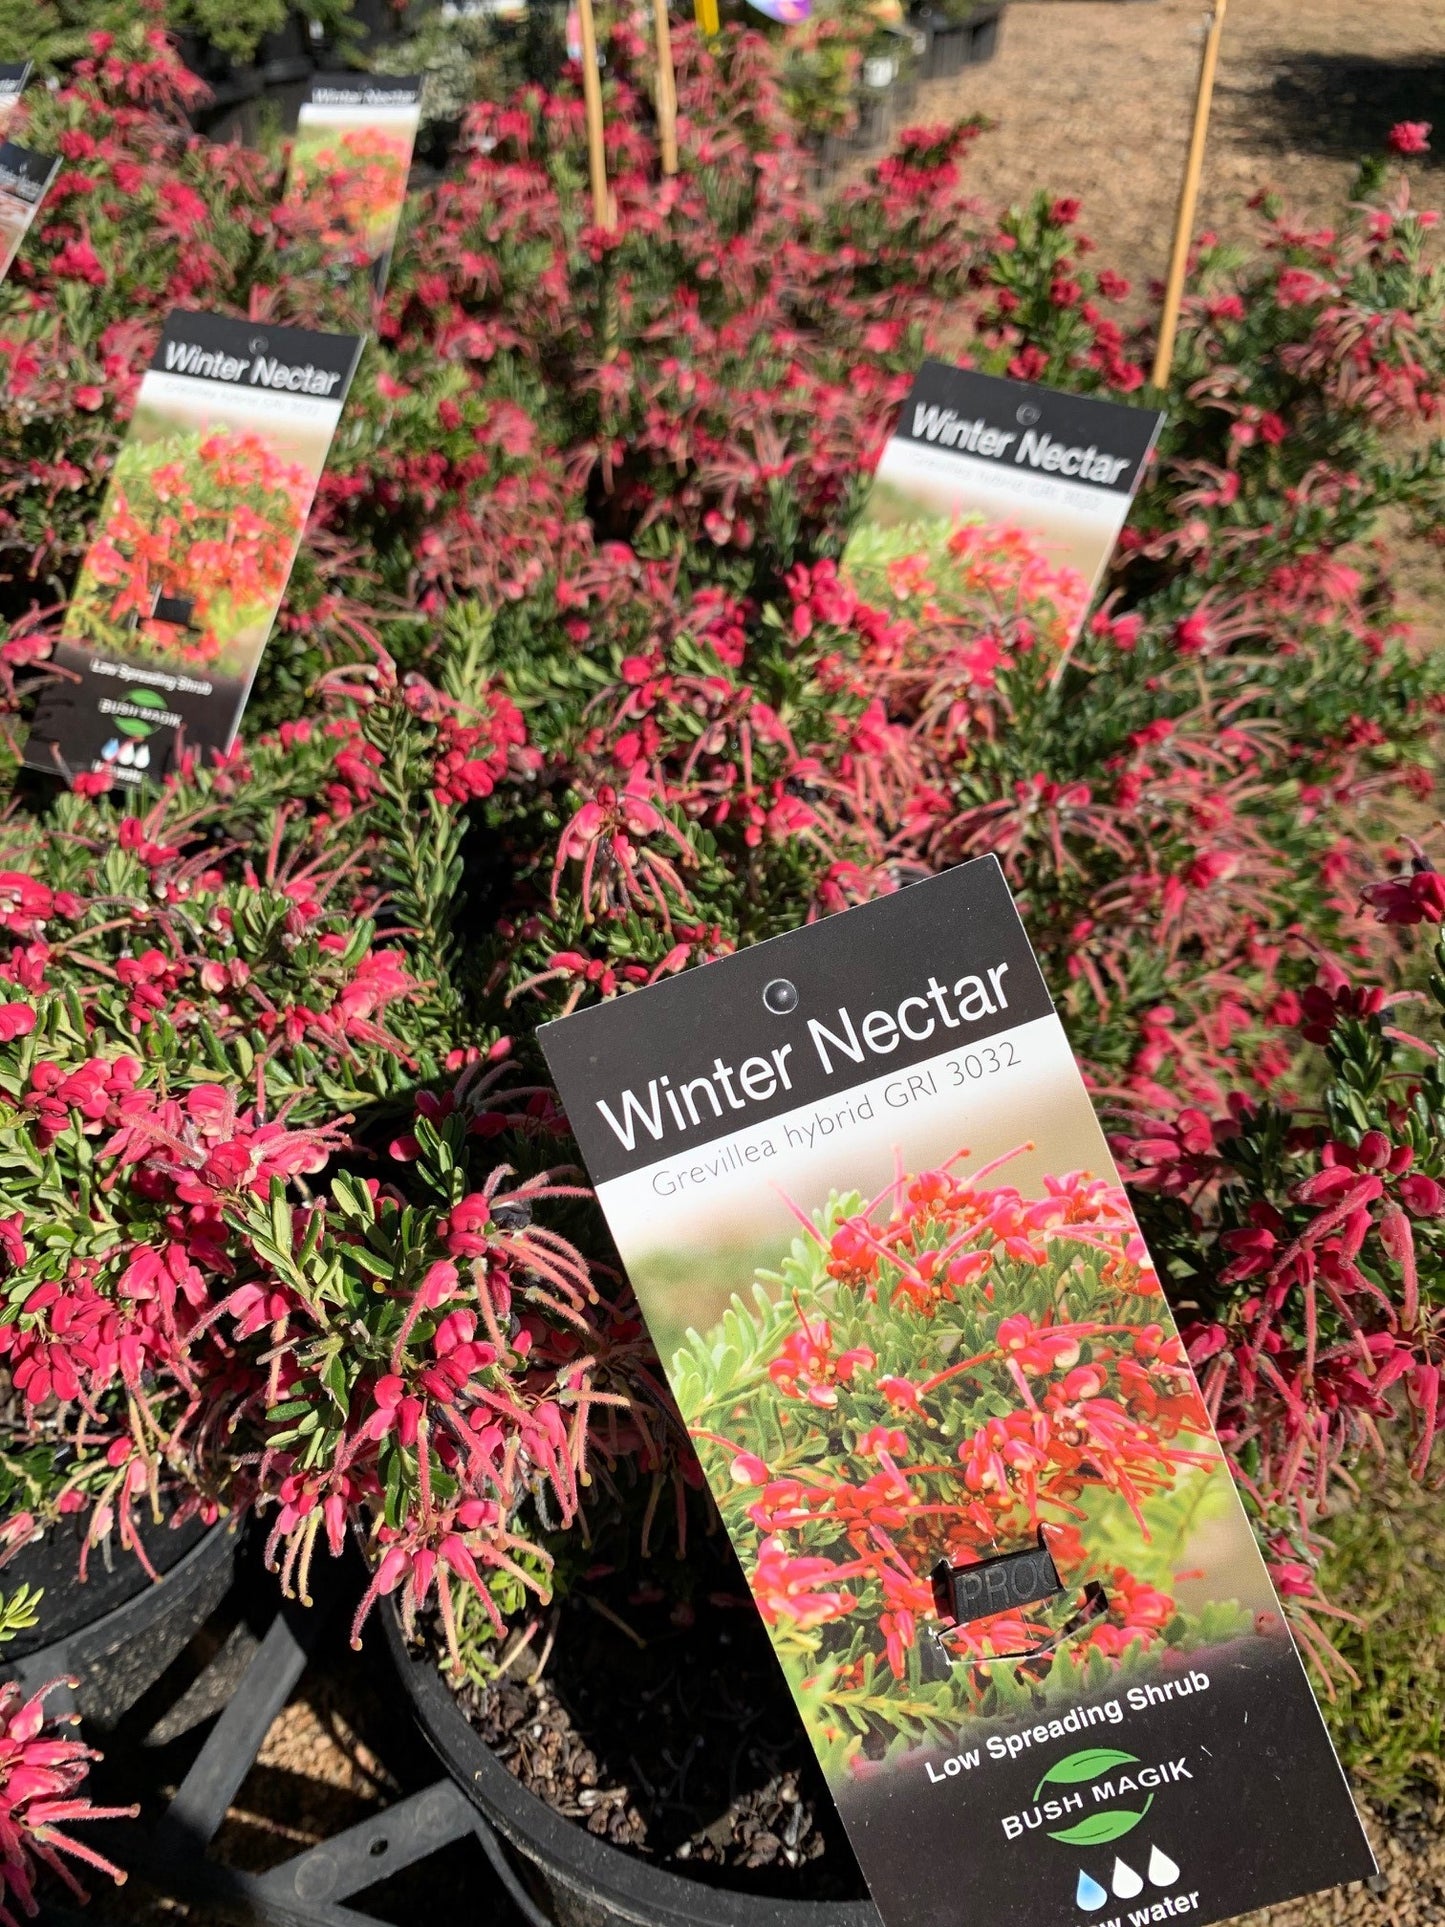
[674,1140,1214,1744]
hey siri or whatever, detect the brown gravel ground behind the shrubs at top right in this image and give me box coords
[915,0,1445,293]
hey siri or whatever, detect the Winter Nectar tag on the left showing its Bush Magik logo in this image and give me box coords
[25,308,362,784]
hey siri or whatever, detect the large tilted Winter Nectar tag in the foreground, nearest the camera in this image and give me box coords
[539,858,1374,1927]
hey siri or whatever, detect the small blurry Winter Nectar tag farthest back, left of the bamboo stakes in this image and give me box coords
[281,73,422,295]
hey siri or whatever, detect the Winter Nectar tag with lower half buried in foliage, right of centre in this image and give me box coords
[844,362,1164,649]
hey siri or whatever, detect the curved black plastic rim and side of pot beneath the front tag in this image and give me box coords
[381,1601,880,1927]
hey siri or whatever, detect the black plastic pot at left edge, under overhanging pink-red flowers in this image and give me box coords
[0,1524,237,1730]
